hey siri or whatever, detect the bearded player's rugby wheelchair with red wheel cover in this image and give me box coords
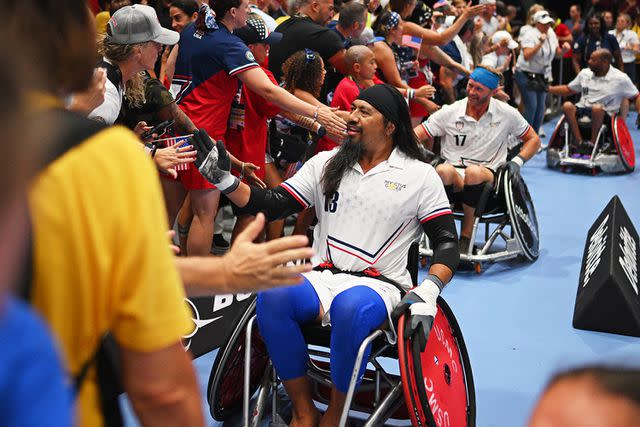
[207,242,475,427]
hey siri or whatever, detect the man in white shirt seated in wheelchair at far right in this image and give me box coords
[549,49,640,146]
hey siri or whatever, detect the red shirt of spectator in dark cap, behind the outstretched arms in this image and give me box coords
[225,67,280,180]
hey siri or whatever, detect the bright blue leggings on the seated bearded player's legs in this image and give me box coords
[257,279,387,393]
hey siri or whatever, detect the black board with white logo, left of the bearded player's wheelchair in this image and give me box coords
[182,294,255,358]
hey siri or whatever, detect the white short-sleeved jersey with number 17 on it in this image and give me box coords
[422,98,529,170]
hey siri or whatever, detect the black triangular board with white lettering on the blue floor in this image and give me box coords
[573,196,640,337]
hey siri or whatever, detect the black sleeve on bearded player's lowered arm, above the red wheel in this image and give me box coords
[422,214,460,274]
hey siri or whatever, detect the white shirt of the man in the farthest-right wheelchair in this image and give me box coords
[569,65,638,114]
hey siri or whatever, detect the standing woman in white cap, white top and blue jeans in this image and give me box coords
[515,10,571,132]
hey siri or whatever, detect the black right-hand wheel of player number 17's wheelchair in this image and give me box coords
[500,169,540,261]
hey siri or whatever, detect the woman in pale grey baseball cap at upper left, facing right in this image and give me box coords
[89,4,180,127]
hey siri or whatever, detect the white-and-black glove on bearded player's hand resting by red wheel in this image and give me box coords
[391,275,442,350]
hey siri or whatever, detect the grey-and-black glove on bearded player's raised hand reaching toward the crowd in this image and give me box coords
[190,129,240,194]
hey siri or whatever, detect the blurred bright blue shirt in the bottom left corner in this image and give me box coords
[0,299,74,427]
